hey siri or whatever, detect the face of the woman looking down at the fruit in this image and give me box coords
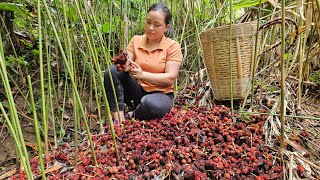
[144,10,169,41]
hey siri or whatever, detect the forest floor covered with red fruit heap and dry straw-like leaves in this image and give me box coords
[0,76,320,179]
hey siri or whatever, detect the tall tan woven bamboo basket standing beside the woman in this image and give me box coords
[201,21,257,100]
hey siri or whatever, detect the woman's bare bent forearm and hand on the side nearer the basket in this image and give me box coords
[130,61,180,86]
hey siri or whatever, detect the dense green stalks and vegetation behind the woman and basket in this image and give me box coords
[0,0,320,178]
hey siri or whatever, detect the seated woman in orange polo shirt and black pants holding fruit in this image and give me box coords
[104,3,183,123]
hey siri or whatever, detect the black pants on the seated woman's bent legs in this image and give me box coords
[104,65,173,120]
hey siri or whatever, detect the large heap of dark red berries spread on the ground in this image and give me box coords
[12,106,283,179]
